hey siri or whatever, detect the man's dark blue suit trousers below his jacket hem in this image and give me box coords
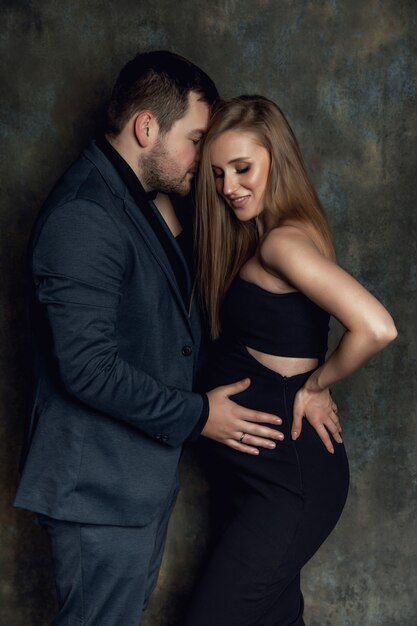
[38,480,178,626]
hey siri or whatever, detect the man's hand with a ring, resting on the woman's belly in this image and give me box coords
[201,378,284,454]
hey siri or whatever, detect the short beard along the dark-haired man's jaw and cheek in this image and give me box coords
[140,139,191,196]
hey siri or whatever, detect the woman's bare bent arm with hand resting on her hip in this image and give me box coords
[261,226,397,452]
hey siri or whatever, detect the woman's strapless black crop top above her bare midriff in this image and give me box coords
[222,276,330,363]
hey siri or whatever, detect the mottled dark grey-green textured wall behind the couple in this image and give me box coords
[0,0,417,626]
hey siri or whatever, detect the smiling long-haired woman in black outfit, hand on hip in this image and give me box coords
[186,96,397,626]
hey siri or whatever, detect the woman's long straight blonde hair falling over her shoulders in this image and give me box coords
[196,96,334,339]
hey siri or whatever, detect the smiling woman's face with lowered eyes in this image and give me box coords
[210,130,271,222]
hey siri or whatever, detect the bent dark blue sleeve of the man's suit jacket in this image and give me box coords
[32,200,203,447]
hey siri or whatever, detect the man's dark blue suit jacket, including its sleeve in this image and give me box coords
[15,142,203,525]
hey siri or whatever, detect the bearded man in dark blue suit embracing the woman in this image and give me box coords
[16,51,278,626]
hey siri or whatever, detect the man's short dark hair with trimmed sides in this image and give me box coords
[106,50,218,136]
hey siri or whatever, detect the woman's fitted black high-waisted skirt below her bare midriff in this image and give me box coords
[185,346,349,626]
